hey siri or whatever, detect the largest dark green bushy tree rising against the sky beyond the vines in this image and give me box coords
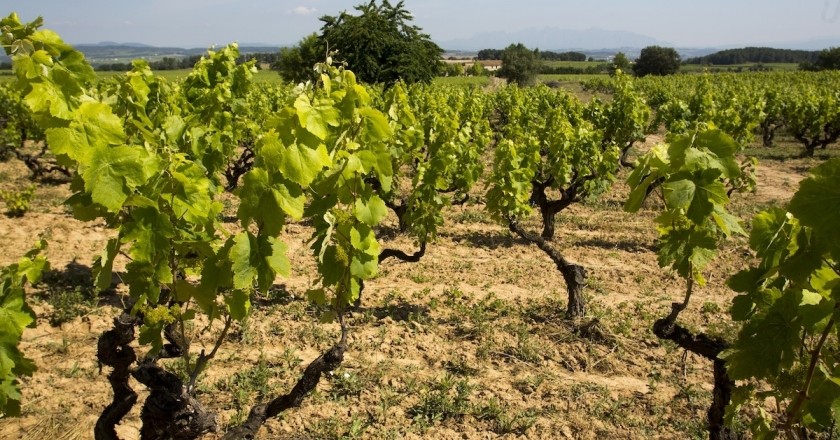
[321,0,443,84]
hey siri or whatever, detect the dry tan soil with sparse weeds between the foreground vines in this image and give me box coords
[0,144,818,440]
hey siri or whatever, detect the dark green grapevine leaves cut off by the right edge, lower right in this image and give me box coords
[721,159,840,438]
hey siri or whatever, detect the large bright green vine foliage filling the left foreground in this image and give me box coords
[0,14,393,432]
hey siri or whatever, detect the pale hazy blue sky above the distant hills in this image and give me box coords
[0,0,840,47]
